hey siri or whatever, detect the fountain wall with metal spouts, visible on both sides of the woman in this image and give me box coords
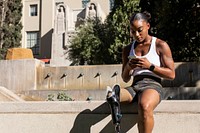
[37,62,200,90]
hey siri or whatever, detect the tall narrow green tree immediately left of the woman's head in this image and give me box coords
[108,0,140,63]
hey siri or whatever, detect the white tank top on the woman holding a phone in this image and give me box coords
[129,37,160,77]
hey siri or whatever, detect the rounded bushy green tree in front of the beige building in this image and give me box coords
[68,18,114,65]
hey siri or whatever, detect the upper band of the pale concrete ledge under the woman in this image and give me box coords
[0,100,200,114]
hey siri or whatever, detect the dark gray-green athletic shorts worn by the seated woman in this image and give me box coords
[126,78,164,101]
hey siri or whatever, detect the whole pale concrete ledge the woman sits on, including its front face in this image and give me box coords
[0,100,200,133]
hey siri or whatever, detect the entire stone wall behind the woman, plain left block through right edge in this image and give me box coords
[0,59,200,92]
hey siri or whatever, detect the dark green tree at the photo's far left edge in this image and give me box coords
[0,0,22,59]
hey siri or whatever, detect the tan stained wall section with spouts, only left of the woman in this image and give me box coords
[37,65,131,90]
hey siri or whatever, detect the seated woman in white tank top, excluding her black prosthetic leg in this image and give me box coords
[120,12,175,133]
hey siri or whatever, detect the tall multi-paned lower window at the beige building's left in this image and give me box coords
[27,32,40,55]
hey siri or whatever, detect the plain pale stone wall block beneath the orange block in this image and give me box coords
[0,59,44,92]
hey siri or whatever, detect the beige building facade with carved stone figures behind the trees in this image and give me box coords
[22,0,112,65]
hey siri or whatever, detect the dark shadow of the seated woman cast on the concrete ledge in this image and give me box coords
[70,102,138,133]
